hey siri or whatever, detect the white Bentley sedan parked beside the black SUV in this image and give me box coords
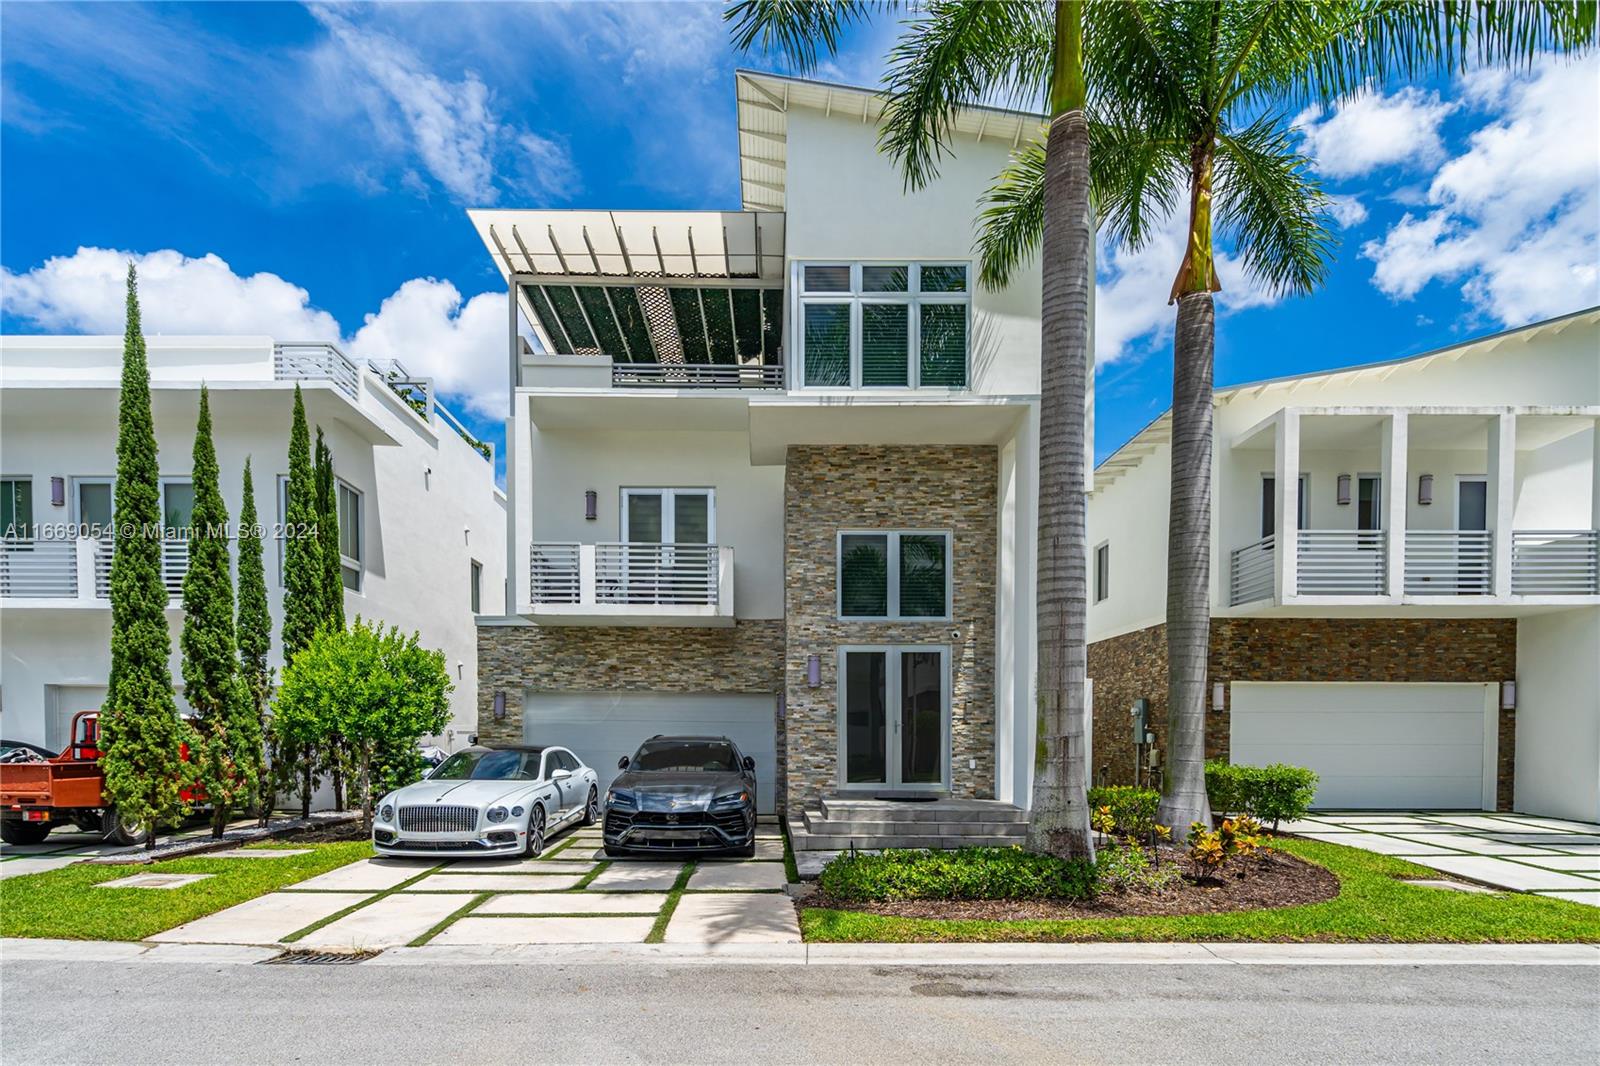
[373,746,600,858]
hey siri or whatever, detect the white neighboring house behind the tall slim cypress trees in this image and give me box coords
[0,336,506,765]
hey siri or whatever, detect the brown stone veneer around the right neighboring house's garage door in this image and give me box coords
[1090,618,1517,810]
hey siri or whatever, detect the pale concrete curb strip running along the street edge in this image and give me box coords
[0,940,1600,967]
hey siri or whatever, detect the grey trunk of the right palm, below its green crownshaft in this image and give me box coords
[1157,288,1216,840]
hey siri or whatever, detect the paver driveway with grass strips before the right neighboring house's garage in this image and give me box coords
[1282,810,1600,908]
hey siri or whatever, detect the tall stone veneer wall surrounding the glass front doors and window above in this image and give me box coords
[784,445,1000,813]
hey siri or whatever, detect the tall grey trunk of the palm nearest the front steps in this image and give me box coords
[1027,3,1094,860]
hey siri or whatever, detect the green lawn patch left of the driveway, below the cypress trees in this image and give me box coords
[0,840,373,940]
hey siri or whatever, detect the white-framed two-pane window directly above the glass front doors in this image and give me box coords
[835,530,950,621]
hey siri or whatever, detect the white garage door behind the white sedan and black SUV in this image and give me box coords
[522,691,778,815]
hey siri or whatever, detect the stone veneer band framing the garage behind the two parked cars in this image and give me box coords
[478,618,786,797]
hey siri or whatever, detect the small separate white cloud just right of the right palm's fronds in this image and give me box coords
[1293,86,1456,178]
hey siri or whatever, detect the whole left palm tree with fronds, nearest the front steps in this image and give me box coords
[726,0,1094,860]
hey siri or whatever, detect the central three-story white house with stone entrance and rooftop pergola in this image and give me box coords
[470,72,1062,839]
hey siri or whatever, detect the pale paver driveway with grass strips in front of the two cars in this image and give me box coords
[150,826,800,951]
